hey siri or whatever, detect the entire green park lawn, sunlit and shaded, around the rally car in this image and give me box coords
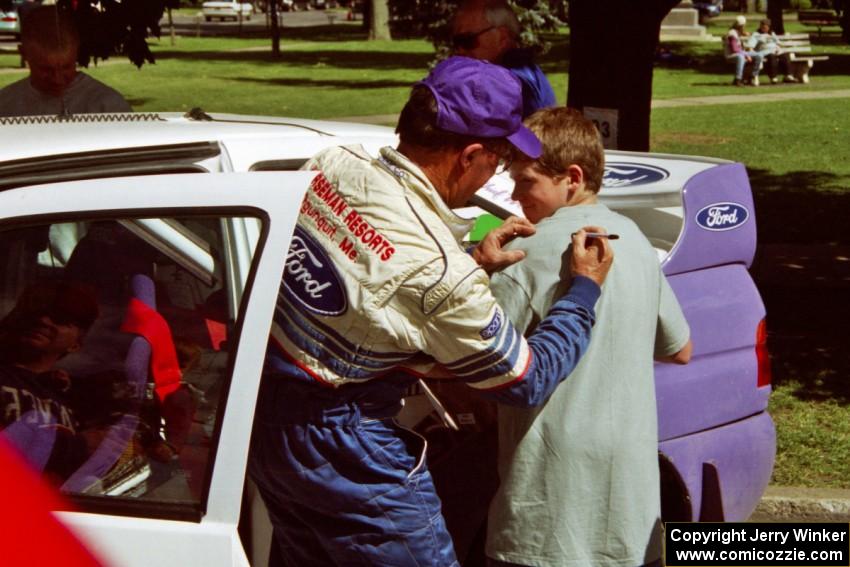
[0,15,850,488]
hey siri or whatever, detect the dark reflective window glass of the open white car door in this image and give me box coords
[0,214,262,519]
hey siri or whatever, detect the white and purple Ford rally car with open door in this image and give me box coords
[0,113,775,567]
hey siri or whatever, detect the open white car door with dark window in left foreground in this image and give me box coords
[0,172,313,567]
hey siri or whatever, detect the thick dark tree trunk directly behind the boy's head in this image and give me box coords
[567,0,679,152]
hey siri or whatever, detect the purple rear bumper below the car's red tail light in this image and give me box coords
[659,412,776,522]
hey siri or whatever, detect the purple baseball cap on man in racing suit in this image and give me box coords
[417,56,543,159]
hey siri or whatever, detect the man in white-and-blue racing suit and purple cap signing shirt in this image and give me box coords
[249,57,612,567]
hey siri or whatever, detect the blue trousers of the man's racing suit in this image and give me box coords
[249,374,459,567]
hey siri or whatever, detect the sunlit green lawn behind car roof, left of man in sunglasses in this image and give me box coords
[0,29,433,118]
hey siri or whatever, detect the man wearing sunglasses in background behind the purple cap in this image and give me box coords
[452,0,557,118]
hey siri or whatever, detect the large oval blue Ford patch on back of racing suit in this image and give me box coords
[283,226,348,315]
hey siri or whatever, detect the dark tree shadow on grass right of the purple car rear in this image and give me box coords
[750,166,850,405]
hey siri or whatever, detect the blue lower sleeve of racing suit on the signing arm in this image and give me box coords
[473,276,601,407]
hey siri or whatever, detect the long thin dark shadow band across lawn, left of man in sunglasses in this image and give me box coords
[151,45,434,70]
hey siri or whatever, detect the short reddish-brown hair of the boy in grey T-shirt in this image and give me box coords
[525,107,605,193]
